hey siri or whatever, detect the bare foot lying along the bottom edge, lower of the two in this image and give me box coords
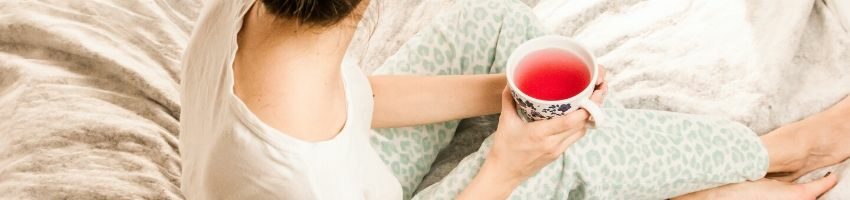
[673,175,838,200]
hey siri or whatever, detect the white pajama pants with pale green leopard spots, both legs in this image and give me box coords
[364,0,768,199]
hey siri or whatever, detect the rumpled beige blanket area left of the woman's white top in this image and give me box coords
[0,0,200,199]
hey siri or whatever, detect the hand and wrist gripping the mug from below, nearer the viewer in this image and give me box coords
[458,88,588,199]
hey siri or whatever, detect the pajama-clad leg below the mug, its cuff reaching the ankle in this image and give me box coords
[416,109,768,199]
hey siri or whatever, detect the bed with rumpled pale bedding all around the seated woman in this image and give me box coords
[0,0,850,199]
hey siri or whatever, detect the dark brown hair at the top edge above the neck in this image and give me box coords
[262,0,361,26]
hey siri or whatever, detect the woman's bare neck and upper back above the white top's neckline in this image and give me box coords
[233,3,356,141]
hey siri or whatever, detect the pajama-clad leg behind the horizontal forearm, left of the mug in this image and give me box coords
[371,0,545,199]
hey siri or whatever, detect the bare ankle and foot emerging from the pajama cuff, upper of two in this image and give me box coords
[762,97,850,181]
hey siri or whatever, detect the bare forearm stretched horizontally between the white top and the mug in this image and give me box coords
[369,74,507,128]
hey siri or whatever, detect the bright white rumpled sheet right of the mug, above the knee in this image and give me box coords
[535,0,850,199]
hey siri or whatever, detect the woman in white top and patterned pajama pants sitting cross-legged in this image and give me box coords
[180,0,850,199]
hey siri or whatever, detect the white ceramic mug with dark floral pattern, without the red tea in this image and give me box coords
[506,35,605,126]
